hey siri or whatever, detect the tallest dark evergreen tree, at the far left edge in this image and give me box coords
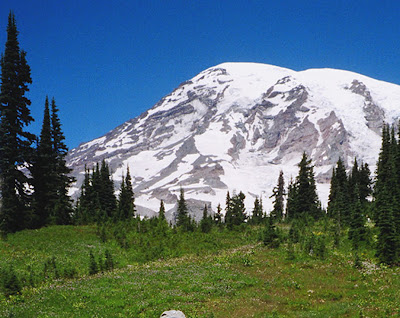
[0,12,36,233]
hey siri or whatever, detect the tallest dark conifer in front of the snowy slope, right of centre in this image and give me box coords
[287,152,322,219]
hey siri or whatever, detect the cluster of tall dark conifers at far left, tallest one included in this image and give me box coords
[0,12,73,234]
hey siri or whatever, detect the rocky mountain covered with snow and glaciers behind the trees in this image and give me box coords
[68,63,400,220]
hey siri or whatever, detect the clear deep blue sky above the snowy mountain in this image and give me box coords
[0,0,400,148]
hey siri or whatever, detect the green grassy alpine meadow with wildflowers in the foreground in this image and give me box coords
[0,222,400,318]
